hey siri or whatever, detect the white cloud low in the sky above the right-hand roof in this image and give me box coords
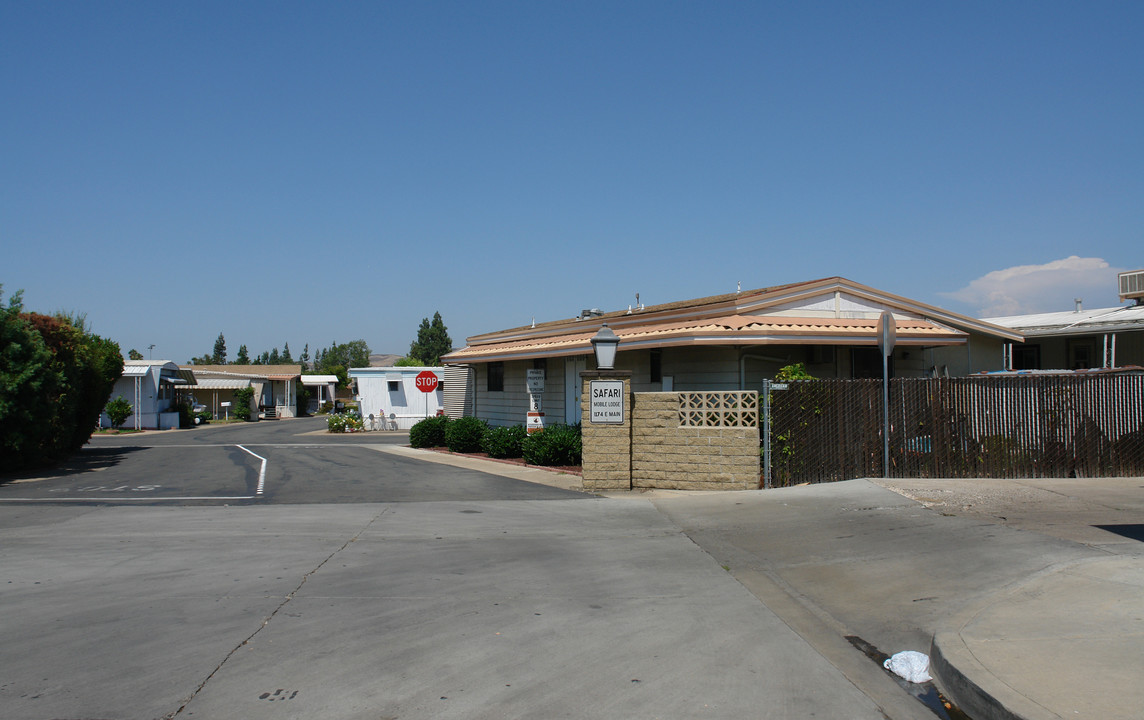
[938,255,1121,317]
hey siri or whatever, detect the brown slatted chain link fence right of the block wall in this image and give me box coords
[762,374,1144,486]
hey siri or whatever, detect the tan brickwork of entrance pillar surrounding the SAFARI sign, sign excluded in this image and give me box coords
[580,370,631,490]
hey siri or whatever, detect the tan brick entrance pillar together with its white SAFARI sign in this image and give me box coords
[580,370,631,490]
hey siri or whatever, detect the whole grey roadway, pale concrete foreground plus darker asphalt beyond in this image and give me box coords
[0,419,931,720]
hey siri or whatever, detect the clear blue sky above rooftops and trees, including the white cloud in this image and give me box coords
[0,0,1144,363]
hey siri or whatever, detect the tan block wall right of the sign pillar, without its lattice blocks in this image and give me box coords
[626,393,760,490]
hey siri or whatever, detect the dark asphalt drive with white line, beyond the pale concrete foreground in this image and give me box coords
[0,418,585,505]
